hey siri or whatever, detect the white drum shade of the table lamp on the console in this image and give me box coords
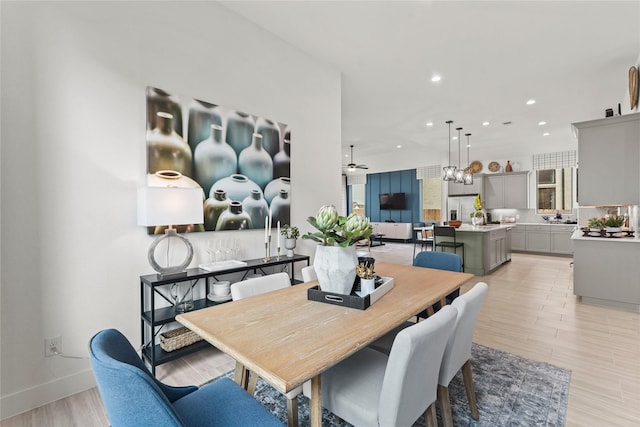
[138,187,204,226]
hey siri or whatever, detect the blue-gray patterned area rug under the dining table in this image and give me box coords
[215,343,571,427]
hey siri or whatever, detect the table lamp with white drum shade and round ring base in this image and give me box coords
[138,187,204,277]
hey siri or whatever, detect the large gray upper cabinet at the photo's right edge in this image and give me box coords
[573,113,640,206]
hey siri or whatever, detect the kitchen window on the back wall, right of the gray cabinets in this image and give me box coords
[536,168,573,214]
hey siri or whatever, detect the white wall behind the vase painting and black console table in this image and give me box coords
[0,2,342,419]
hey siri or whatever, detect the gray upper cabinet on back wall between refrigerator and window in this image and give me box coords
[484,172,529,209]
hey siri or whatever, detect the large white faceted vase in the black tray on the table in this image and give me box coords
[313,246,358,295]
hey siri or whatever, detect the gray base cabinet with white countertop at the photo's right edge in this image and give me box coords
[571,230,640,311]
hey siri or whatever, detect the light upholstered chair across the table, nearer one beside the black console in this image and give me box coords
[231,272,302,427]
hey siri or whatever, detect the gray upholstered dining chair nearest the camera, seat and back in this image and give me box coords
[304,306,457,427]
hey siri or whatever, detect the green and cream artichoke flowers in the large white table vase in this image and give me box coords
[302,205,373,248]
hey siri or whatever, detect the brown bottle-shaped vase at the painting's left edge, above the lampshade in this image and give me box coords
[147,112,192,176]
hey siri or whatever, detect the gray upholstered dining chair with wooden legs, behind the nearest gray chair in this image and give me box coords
[438,282,489,427]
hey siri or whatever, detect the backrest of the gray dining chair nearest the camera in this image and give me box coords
[378,306,457,426]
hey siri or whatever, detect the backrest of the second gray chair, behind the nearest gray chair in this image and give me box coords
[438,282,489,387]
